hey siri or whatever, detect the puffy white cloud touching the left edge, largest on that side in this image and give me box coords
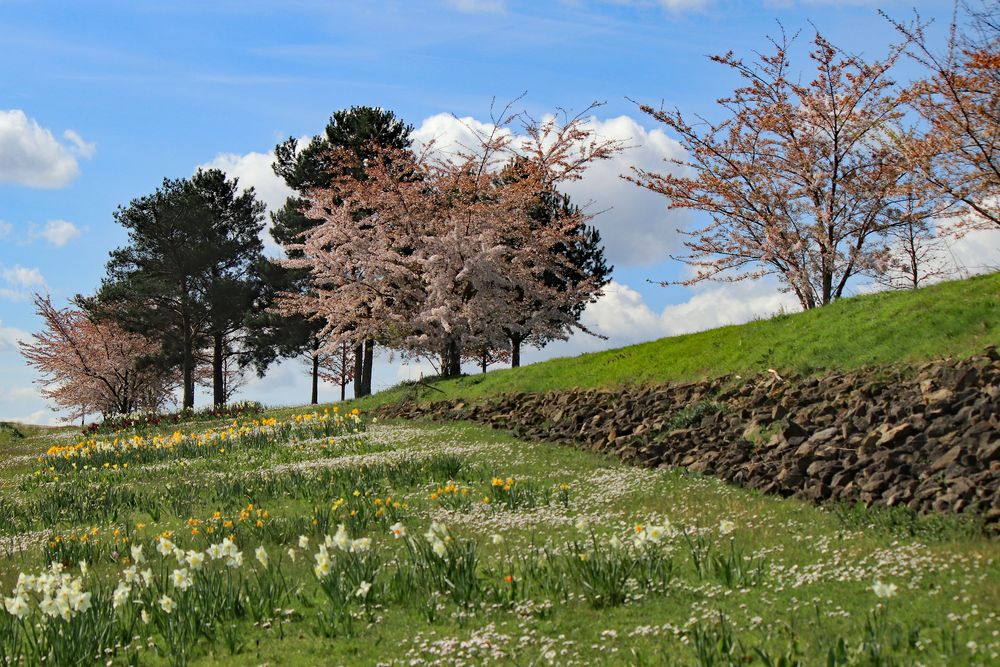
[0,109,93,188]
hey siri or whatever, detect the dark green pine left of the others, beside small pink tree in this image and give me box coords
[91,170,264,408]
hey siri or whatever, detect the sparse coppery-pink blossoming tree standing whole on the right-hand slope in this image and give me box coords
[630,34,924,309]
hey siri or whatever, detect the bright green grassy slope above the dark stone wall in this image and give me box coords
[359,273,1000,409]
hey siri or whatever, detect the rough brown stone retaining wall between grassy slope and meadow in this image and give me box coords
[380,347,1000,532]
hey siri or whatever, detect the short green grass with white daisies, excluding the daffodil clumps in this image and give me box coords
[0,414,1000,667]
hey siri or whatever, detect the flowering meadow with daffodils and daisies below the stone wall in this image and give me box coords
[0,406,1000,666]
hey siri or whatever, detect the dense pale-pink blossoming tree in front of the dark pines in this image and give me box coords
[283,103,621,375]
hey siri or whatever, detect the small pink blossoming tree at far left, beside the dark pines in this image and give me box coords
[19,295,178,420]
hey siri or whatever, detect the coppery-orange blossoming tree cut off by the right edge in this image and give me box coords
[890,3,1000,233]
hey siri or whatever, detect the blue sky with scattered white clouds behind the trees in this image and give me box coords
[0,0,984,421]
